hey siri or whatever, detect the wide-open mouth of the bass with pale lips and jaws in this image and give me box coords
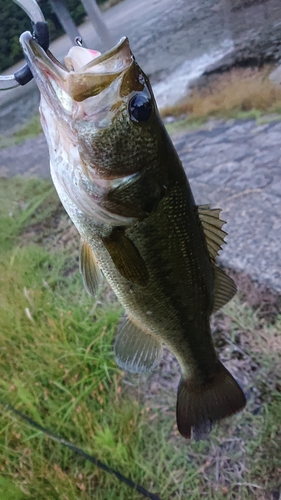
[20,31,134,102]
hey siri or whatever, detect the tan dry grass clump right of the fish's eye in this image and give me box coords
[161,65,281,118]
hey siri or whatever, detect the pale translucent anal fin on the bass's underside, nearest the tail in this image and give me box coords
[114,318,162,373]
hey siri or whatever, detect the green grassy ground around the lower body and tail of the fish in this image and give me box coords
[0,178,281,500]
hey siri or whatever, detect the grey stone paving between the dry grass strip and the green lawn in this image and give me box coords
[0,121,281,292]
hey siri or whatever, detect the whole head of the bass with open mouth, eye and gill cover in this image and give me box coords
[20,32,165,225]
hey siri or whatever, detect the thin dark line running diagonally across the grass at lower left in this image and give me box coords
[0,400,161,500]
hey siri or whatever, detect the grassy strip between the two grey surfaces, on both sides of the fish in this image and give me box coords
[0,64,281,149]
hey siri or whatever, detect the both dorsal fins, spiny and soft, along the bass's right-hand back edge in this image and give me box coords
[198,205,237,313]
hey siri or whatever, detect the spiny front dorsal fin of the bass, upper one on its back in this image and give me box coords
[198,205,227,260]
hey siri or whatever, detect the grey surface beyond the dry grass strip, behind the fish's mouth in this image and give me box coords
[0,0,281,134]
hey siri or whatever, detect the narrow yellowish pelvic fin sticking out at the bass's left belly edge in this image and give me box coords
[80,241,102,295]
